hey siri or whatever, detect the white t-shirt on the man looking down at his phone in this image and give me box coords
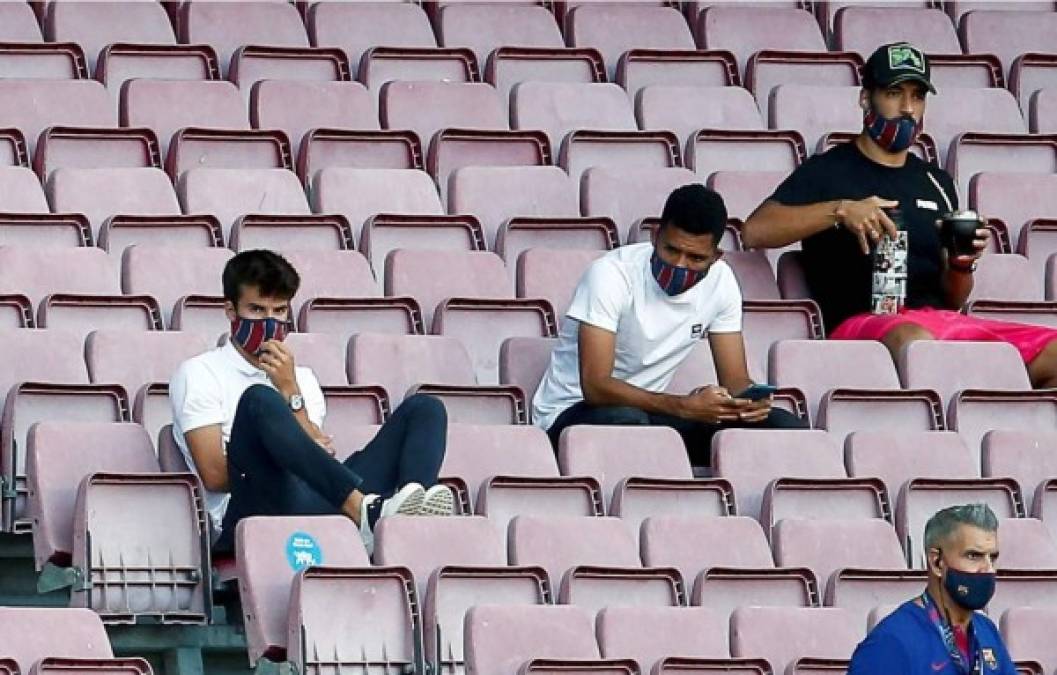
[533,242,741,429]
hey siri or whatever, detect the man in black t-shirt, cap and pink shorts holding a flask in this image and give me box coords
[742,42,1057,388]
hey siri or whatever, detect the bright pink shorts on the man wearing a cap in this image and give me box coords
[830,307,1057,363]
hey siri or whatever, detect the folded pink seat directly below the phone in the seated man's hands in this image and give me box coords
[712,429,884,531]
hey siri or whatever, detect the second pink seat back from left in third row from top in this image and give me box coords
[48,166,180,242]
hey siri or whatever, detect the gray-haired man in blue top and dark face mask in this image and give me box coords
[848,504,1017,675]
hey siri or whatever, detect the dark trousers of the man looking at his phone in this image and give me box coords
[546,401,808,466]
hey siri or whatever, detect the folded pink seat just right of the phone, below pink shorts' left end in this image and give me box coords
[768,340,944,440]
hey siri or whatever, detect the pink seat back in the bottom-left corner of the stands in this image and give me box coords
[0,607,113,673]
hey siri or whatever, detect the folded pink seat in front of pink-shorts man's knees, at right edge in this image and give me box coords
[898,341,1057,450]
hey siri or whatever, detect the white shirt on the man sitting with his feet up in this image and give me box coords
[169,342,327,532]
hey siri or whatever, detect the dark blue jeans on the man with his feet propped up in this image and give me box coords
[215,385,448,551]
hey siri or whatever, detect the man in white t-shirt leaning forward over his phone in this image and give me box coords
[533,184,805,466]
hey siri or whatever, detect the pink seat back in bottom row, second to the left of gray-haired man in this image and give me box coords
[596,607,730,673]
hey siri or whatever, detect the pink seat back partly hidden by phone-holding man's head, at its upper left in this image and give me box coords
[580,167,697,241]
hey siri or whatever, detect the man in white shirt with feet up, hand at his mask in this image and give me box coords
[169,250,453,552]
